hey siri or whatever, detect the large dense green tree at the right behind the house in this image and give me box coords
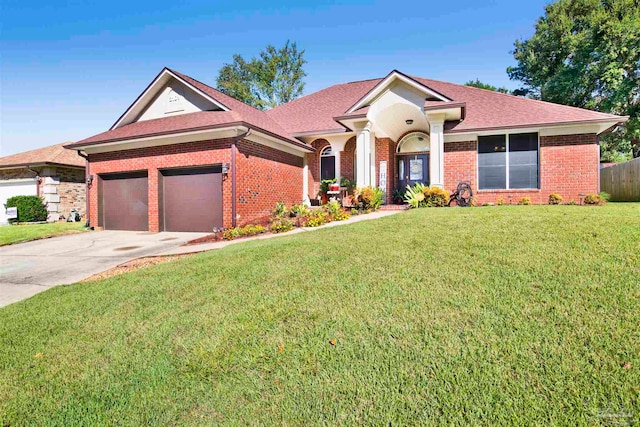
[507,0,640,160]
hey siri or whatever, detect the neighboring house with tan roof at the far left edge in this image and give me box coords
[0,142,86,224]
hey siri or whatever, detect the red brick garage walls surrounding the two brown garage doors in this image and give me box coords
[89,139,302,232]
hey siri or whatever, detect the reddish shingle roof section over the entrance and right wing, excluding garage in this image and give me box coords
[267,77,622,134]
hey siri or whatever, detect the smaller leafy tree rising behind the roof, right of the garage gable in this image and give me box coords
[216,40,307,110]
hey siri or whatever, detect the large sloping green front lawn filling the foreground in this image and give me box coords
[0,204,640,426]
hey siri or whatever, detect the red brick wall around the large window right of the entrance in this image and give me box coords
[444,134,600,204]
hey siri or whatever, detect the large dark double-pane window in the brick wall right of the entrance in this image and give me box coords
[478,133,540,190]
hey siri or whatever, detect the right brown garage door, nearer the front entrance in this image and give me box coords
[161,167,222,232]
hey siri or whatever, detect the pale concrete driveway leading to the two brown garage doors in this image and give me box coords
[0,231,207,307]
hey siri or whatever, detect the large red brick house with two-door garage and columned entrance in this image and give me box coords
[68,68,627,232]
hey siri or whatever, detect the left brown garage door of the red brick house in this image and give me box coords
[98,172,149,231]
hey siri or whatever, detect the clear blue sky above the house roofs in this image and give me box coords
[0,0,547,155]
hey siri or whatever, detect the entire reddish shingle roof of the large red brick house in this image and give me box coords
[70,68,624,153]
